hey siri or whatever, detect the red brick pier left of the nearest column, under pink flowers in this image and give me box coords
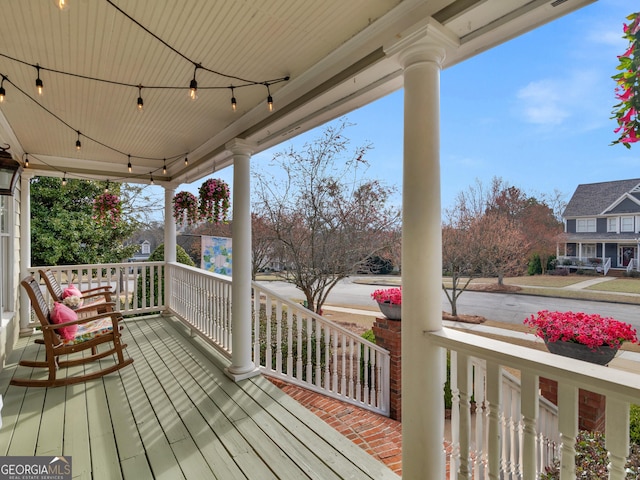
[373,317,402,421]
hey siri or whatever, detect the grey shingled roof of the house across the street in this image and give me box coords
[562,178,640,218]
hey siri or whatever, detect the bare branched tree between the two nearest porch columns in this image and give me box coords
[254,122,400,312]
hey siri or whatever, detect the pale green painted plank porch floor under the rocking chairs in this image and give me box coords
[0,317,399,480]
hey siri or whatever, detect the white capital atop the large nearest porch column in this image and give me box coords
[384,18,460,69]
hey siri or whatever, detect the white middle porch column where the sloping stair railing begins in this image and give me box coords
[225,139,259,381]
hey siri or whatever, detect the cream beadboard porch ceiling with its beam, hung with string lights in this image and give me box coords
[0,0,593,184]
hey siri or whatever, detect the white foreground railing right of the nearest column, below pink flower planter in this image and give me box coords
[426,328,640,480]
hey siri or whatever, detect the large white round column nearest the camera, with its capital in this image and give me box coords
[387,23,455,479]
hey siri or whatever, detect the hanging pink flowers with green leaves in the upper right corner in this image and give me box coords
[611,13,640,148]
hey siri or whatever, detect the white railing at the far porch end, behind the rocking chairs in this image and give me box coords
[28,262,164,315]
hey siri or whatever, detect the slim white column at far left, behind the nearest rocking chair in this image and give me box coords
[18,171,33,335]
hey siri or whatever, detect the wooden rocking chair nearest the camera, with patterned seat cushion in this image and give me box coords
[11,275,133,387]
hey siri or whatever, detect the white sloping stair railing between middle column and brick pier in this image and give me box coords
[253,283,390,415]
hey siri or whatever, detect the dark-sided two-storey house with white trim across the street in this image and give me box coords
[558,178,640,275]
